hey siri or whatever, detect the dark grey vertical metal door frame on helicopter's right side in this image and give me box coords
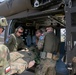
[65,0,76,63]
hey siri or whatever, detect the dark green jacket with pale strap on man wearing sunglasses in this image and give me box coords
[6,33,26,52]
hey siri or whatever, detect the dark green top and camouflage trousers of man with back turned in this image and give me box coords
[35,32,59,75]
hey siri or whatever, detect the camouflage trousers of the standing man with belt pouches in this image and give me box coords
[35,59,56,75]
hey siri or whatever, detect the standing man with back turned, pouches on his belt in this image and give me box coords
[35,25,59,75]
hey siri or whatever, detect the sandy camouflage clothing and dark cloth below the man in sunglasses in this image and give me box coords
[10,51,35,74]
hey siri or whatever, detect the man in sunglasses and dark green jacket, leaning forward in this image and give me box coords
[6,26,26,52]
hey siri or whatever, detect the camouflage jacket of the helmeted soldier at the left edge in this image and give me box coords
[0,45,10,75]
